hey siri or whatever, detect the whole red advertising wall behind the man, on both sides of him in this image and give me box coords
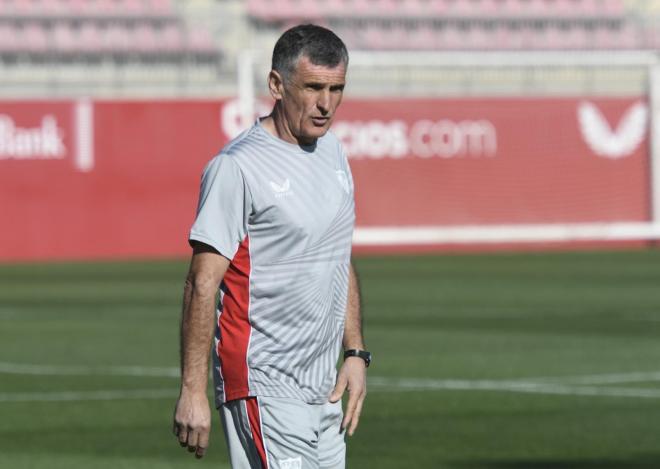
[0,97,658,261]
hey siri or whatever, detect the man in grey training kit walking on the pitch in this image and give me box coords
[174,25,371,469]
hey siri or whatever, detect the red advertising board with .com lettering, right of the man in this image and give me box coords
[335,99,649,226]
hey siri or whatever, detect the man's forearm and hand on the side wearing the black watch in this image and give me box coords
[330,264,367,436]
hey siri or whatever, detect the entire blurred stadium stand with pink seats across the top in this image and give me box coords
[0,0,660,98]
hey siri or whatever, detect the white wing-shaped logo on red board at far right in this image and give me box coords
[577,101,649,159]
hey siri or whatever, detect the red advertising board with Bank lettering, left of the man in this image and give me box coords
[0,101,226,261]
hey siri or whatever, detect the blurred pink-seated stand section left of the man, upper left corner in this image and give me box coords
[0,0,232,97]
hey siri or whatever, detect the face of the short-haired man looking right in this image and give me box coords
[276,56,346,145]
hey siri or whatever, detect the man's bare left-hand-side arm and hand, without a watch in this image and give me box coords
[173,243,229,458]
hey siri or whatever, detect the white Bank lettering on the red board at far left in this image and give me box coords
[0,114,66,160]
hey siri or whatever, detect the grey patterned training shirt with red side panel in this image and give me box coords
[190,121,355,406]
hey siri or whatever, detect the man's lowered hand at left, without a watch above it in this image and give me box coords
[173,390,211,458]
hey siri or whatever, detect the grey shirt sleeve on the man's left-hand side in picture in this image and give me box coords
[188,154,251,260]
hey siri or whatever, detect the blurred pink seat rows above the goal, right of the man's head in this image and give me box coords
[248,0,660,50]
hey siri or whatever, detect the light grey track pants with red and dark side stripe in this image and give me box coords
[220,397,346,469]
